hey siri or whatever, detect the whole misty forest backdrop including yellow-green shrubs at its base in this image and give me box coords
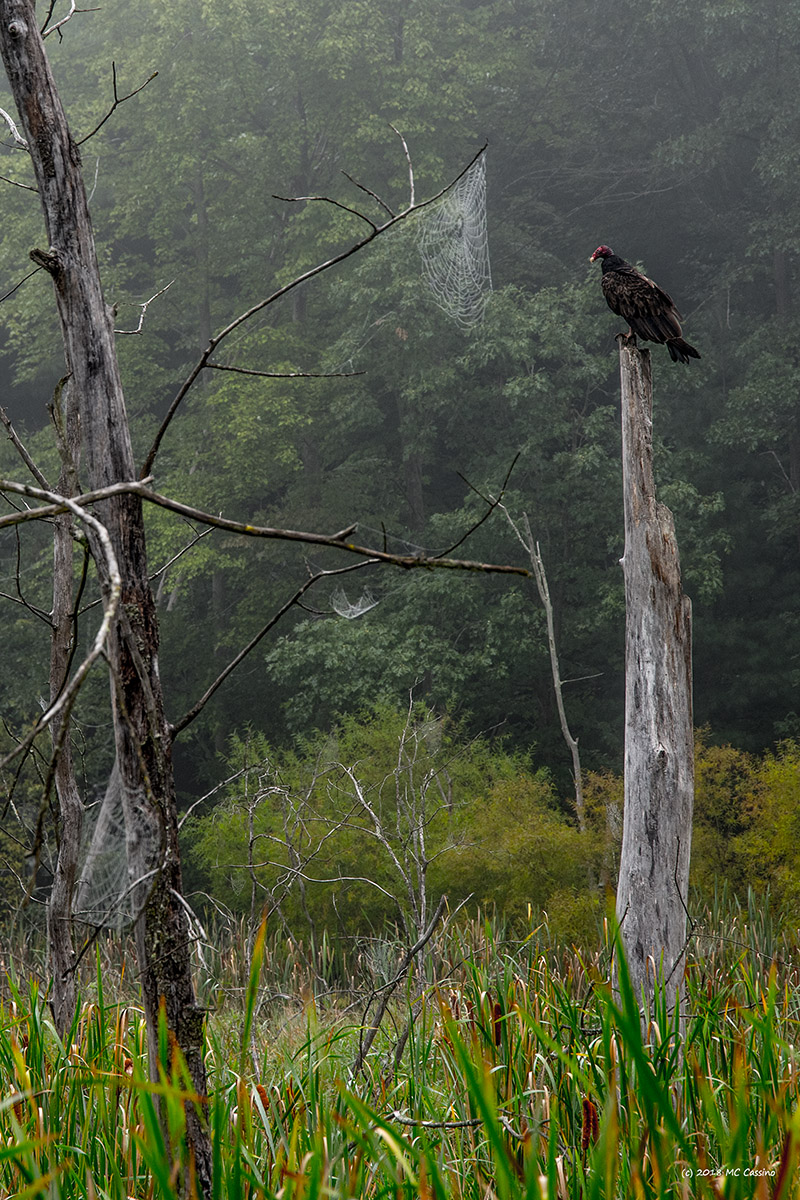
[0,0,800,936]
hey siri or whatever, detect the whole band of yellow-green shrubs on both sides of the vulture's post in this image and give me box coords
[185,706,800,947]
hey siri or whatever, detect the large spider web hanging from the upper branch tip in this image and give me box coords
[417,152,492,329]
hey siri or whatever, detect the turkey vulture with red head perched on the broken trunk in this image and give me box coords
[589,246,700,362]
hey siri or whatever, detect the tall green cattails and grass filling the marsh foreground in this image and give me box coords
[0,904,800,1200]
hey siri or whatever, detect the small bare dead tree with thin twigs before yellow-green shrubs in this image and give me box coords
[200,697,467,1075]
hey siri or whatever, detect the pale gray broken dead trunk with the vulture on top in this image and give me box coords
[616,338,694,1027]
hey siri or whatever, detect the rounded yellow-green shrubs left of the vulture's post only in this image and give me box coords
[185,706,599,943]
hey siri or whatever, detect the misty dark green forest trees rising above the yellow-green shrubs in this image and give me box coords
[0,0,800,794]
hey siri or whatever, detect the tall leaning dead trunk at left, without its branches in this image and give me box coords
[0,0,211,1195]
